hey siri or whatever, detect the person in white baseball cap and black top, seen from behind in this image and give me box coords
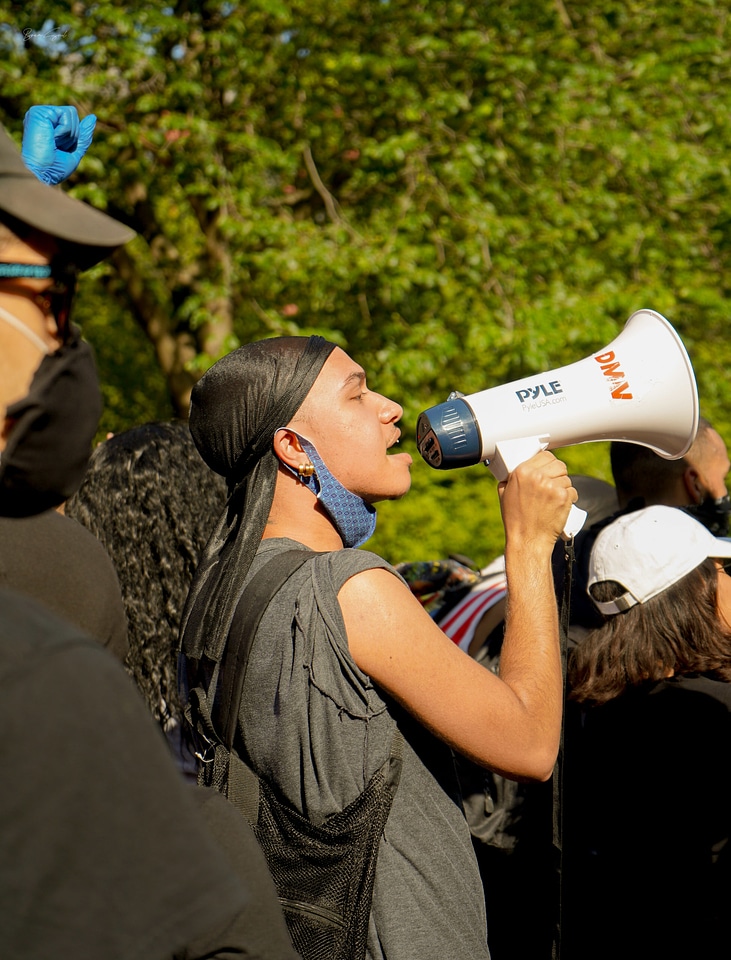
[563,506,731,960]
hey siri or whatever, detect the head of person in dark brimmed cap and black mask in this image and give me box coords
[0,111,134,516]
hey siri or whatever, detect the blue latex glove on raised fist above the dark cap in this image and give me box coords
[21,106,96,185]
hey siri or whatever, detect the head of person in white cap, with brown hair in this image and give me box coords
[571,506,731,703]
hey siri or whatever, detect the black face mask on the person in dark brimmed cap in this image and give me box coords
[0,326,102,517]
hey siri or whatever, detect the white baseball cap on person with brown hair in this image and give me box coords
[588,506,731,615]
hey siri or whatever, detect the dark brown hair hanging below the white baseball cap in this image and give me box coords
[568,560,731,706]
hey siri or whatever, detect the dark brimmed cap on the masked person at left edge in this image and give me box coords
[0,126,135,270]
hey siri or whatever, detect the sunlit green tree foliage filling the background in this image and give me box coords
[0,0,731,563]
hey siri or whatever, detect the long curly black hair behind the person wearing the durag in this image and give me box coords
[65,421,226,729]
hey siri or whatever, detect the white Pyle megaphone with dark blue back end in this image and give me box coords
[416,310,699,537]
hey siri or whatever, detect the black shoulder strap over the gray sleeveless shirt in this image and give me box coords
[211,550,314,751]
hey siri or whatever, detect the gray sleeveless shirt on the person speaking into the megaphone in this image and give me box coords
[239,539,489,960]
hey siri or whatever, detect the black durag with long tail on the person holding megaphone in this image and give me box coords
[181,337,335,661]
